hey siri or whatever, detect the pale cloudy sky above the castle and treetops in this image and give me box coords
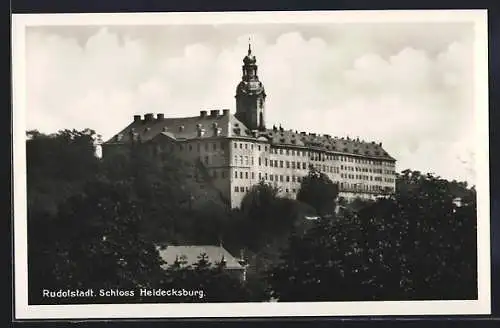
[26,22,475,184]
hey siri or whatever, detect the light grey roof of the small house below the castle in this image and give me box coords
[159,245,243,270]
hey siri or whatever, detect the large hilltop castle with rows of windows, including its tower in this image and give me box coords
[102,45,396,207]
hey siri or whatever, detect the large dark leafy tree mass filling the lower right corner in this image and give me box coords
[269,171,477,301]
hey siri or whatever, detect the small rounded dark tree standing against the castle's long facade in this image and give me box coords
[297,166,339,215]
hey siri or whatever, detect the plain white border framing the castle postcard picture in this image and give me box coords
[12,10,491,319]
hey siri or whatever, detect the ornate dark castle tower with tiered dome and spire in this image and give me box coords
[235,42,266,130]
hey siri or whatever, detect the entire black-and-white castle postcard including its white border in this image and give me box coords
[13,10,490,319]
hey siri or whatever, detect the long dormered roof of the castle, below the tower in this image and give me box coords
[106,110,395,161]
